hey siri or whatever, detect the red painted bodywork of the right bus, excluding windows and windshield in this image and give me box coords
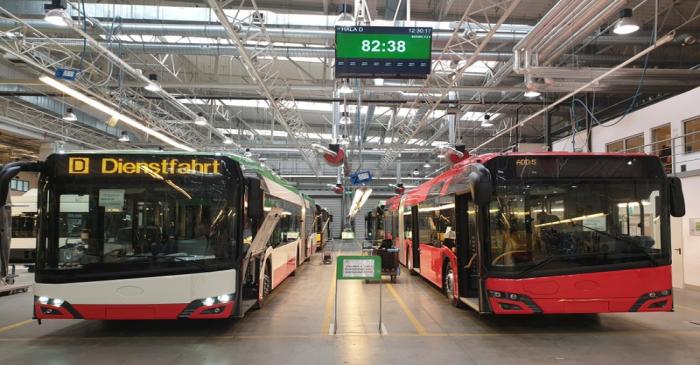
[385,153,673,314]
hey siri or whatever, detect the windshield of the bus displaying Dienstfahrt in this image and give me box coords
[39,154,238,273]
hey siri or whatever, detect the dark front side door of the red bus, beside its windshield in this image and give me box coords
[455,194,480,304]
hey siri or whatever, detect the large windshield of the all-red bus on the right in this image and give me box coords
[488,179,670,275]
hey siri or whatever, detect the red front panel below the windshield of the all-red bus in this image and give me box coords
[486,266,673,314]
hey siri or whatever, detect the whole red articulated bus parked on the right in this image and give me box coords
[385,153,685,314]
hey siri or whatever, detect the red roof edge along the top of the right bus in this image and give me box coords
[386,151,649,211]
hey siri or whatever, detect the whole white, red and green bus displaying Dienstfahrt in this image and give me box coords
[0,151,316,319]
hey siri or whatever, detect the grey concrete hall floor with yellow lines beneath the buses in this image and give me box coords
[0,239,700,365]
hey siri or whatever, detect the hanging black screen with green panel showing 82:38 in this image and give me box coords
[335,26,433,78]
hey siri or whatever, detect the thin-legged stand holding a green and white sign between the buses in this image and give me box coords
[333,256,382,335]
